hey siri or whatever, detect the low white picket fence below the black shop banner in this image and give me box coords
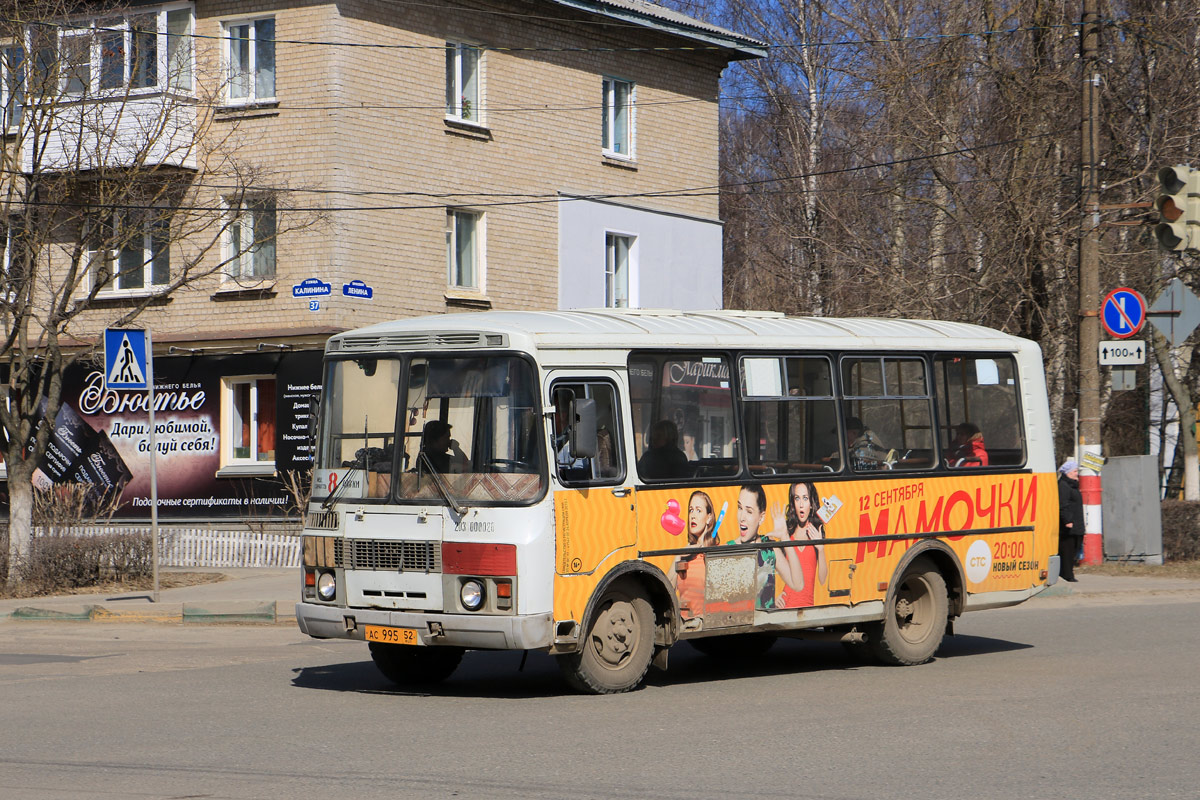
[35,525,300,567]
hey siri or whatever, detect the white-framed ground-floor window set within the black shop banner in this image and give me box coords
[221,375,275,467]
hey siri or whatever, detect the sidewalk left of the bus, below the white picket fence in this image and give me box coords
[0,569,300,625]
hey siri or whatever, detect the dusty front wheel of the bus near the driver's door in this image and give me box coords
[558,581,654,694]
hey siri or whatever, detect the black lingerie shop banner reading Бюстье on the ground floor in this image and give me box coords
[8,351,322,519]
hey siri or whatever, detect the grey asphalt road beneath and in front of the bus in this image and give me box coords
[0,596,1200,800]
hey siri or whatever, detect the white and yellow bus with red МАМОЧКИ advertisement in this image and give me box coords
[296,311,1058,692]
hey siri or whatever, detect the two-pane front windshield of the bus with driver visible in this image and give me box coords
[317,356,546,505]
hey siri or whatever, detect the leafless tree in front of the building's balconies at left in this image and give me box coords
[0,0,316,582]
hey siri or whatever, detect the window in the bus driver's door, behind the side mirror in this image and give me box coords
[551,380,625,486]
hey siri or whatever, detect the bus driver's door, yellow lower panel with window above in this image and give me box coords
[547,371,637,576]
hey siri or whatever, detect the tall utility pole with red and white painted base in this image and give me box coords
[1078,0,1104,564]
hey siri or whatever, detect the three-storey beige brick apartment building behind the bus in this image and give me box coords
[0,0,764,521]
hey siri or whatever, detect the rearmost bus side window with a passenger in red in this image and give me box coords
[934,354,1026,469]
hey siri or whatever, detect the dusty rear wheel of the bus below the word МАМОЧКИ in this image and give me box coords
[869,558,949,666]
